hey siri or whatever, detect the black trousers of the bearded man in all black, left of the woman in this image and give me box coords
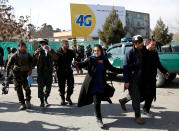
[57,71,74,98]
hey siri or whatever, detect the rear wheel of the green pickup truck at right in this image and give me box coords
[156,70,166,87]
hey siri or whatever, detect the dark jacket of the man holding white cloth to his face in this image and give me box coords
[33,47,58,74]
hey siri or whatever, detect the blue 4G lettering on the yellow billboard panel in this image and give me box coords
[75,15,92,27]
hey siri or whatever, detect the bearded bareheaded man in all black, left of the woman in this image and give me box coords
[56,40,76,105]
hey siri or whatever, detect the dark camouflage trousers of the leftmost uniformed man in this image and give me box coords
[13,72,31,104]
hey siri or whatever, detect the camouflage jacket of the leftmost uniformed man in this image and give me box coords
[6,51,33,77]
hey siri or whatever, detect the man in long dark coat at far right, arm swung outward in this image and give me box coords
[141,39,169,117]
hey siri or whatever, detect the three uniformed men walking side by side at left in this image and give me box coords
[5,39,76,110]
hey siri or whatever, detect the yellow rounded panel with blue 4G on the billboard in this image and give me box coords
[70,4,96,37]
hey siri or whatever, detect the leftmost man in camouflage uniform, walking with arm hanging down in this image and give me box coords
[6,42,33,110]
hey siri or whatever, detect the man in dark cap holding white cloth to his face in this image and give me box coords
[33,39,57,107]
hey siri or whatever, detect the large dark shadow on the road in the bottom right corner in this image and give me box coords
[107,111,179,131]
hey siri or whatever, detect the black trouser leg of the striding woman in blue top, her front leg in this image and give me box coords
[93,93,102,120]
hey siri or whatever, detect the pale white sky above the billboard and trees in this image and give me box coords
[9,0,179,32]
